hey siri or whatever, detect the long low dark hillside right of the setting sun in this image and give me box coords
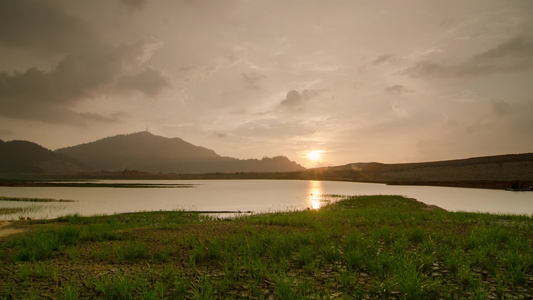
[295,153,533,188]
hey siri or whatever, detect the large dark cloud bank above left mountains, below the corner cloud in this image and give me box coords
[0,39,169,124]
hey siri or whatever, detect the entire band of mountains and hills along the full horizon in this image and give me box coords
[0,132,533,188]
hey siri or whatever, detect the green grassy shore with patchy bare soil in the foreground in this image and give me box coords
[0,196,533,299]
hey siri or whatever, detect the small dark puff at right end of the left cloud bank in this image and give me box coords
[118,67,172,96]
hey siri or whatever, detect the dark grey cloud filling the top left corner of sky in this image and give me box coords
[0,0,100,54]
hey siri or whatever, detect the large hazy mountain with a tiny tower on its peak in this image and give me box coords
[56,131,305,174]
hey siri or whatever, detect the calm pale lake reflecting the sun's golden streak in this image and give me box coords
[0,180,533,220]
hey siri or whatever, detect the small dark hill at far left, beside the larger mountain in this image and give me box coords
[0,140,84,175]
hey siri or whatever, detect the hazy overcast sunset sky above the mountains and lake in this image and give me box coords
[0,0,533,167]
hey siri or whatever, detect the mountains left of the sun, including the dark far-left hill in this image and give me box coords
[0,131,305,174]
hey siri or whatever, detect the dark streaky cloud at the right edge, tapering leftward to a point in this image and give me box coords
[401,37,533,77]
